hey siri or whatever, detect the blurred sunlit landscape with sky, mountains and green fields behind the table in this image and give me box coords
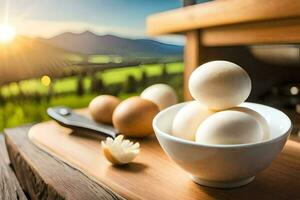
[0,0,184,131]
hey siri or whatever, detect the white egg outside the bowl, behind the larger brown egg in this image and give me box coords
[140,83,178,110]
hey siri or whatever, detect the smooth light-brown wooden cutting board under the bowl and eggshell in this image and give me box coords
[29,111,300,200]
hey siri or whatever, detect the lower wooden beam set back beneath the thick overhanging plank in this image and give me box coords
[201,17,300,46]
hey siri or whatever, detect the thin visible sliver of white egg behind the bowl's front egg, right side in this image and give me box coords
[230,106,270,140]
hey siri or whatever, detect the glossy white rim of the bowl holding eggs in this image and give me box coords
[152,101,293,148]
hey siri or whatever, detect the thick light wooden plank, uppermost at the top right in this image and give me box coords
[147,0,300,36]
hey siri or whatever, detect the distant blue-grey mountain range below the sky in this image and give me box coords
[40,31,183,57]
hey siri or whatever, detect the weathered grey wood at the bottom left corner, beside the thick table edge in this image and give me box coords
[0,133,27,200]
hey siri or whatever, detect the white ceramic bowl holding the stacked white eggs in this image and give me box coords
[153,103,292,188]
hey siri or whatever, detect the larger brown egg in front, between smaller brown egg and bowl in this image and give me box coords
[113,97,159,137]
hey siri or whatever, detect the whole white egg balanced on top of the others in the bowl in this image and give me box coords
[189,61,251,110]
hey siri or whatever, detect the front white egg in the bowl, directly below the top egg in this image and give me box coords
[196,110,263,145]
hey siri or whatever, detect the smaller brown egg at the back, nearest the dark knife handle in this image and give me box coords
[89,95,121,124]
